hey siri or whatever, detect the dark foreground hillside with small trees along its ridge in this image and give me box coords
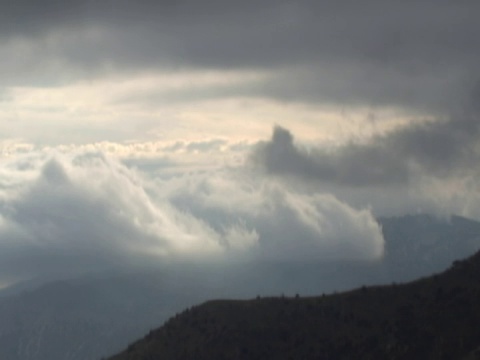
[110,248,480,360]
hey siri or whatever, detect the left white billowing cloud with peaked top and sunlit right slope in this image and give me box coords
[1,156,220,282]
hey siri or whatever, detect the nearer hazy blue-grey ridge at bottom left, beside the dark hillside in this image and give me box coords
[0,273,216,360]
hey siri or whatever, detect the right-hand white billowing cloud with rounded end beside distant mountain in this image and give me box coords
[163,170,383,260]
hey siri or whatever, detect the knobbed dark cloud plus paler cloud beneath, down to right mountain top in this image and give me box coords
[249,123,480,219]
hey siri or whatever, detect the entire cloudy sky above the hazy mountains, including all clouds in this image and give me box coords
[0,0,480,284]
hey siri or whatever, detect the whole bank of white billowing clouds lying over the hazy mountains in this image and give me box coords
[0,152,383,281]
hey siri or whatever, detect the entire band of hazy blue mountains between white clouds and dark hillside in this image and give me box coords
[0,215,480,360]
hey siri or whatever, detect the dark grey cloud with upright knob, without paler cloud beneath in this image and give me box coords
[252,113,480,186]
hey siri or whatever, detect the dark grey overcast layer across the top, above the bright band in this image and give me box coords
[0,0,480,111]
